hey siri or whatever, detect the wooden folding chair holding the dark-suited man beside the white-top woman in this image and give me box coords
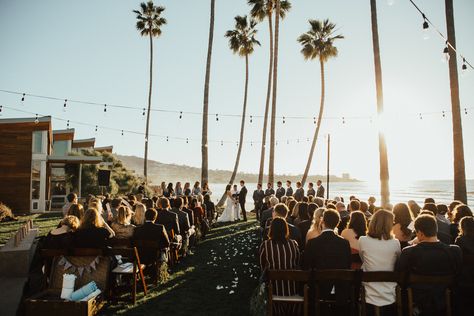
[313,269,358,315]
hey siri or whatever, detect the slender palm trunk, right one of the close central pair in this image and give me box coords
[268,0,280,184]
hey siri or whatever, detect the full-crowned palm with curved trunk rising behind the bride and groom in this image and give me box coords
[218,16,260,205]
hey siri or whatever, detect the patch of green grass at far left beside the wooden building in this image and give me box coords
[0,213,62,247]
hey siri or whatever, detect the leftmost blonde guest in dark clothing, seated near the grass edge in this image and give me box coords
[43,215,80,249]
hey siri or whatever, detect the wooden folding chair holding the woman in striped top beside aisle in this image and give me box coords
[267,270,311,316]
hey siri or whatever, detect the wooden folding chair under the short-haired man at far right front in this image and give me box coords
[406,274,455,316]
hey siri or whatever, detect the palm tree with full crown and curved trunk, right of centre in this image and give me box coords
[298,19,344,185]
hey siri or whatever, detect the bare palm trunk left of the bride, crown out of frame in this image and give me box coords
[201,0,216,183]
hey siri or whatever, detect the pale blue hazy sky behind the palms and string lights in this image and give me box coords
[0,0,474,182]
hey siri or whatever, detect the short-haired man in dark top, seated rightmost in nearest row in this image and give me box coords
[398,215,462,315]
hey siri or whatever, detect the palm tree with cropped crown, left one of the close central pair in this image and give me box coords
[248,0,291,183]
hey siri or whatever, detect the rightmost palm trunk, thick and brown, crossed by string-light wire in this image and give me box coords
[445,0,467,203]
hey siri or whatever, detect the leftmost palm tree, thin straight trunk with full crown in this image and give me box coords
[133,1,166,183]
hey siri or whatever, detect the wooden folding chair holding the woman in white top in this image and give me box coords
[360,271,403,316]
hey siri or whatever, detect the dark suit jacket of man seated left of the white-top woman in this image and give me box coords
[303,231,351,301]
